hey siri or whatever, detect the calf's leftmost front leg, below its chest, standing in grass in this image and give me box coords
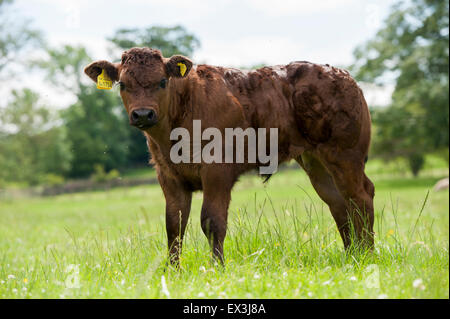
[158,174,192,266]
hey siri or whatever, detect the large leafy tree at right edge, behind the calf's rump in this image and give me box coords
[350,0,449,174]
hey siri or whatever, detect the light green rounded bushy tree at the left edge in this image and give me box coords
[0,89,71,184]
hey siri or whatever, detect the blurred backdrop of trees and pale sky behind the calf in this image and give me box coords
[0,0,449,194]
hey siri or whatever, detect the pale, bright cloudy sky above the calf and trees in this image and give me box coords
[9,0,394,104]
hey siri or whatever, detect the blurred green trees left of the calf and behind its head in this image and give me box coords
[0,1,200,186]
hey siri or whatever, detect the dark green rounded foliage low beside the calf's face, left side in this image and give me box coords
[63,86,129,177]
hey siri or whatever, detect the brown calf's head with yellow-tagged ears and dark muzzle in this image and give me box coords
[84,48,192,130]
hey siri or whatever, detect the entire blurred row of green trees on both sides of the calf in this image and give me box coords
[0,0,449,187]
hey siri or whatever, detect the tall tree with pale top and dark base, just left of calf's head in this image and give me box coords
[36,45,129,177]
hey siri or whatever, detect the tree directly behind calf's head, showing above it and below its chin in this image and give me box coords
[109,26,200,165]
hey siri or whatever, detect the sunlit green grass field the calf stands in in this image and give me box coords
[0,161,449,298]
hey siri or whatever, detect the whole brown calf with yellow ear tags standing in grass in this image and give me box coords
[85,48,374,263]
